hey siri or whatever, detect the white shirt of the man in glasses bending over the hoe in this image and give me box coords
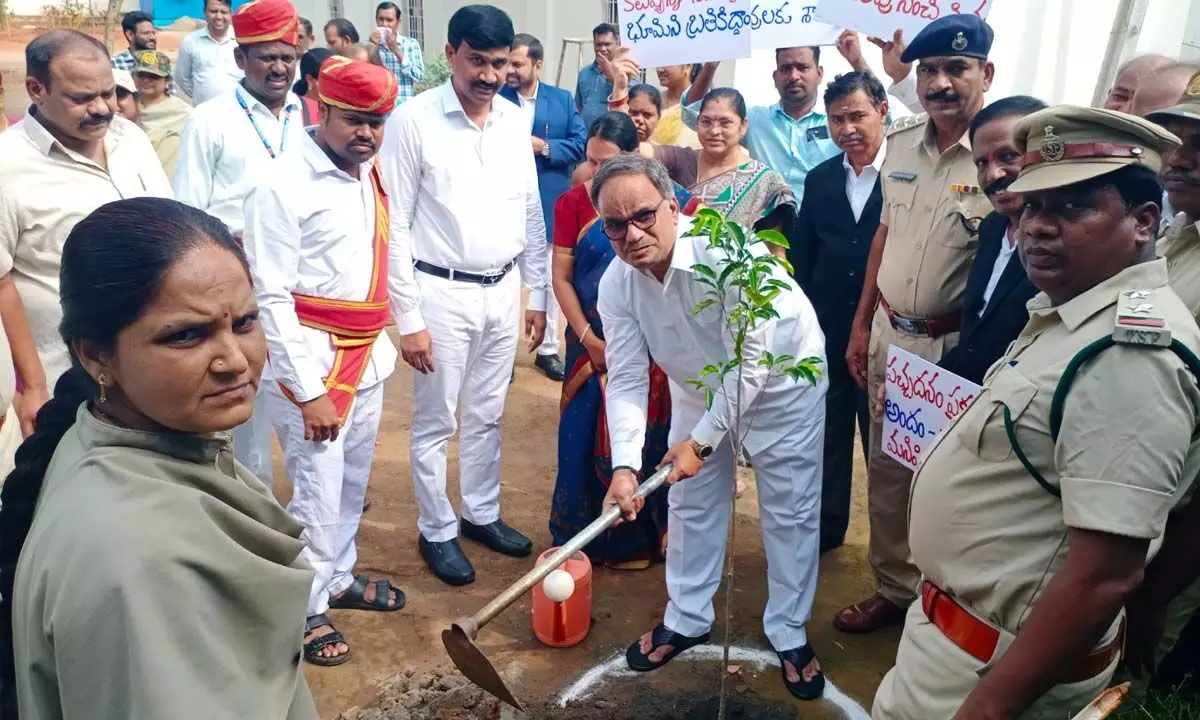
[599,216,824,468]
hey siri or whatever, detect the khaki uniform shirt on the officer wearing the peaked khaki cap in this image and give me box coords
[908,259,1200,634]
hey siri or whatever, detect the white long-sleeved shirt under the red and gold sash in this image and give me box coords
[245,137,396,402]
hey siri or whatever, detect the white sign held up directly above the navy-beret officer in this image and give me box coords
[816,0,995,41]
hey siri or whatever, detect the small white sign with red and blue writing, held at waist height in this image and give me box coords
[878,345,979,469]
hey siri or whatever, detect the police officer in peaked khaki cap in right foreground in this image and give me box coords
[872,106,1200,720]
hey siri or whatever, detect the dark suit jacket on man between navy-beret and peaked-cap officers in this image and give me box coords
[938,212,1038,384]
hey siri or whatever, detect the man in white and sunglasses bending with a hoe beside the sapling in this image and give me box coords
[592,154,827,700]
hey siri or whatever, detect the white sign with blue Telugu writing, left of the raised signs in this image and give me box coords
[617,0,761,67]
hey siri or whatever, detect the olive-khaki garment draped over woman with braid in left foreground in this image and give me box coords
[12,407,318,720]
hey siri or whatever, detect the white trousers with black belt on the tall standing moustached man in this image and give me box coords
[409,271,521,542]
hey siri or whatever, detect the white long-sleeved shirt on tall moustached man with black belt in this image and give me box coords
[379,80,548,335]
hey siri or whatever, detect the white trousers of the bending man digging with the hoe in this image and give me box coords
[664,379,827,652]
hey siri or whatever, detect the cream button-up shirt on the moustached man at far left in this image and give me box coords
[0,114,173,381]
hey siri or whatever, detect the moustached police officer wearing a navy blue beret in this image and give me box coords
[834,14,995,632]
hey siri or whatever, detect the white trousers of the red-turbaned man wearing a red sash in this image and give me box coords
[265,382,383,617]
